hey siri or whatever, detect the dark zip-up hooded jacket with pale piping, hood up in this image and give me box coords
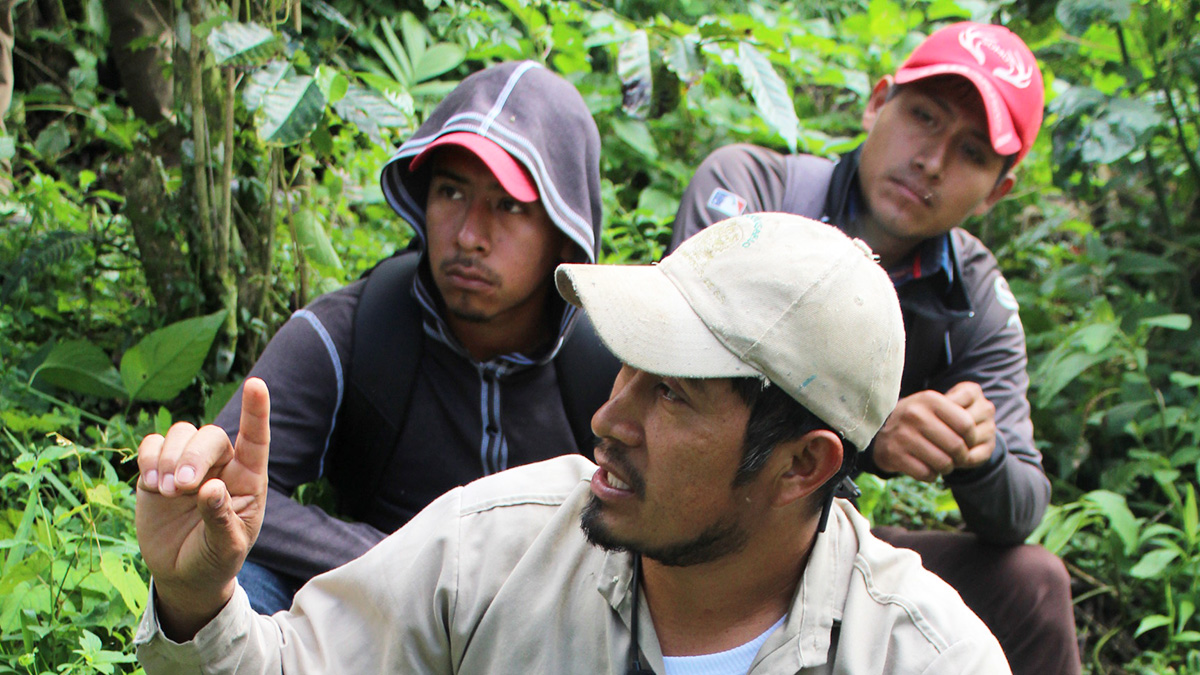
[216,61,609,581]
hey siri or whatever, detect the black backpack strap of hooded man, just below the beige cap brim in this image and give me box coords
[554,310,620,459]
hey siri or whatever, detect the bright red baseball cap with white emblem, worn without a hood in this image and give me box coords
[895,22,1045,162]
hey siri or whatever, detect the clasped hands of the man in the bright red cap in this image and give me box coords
[874,382,996,482]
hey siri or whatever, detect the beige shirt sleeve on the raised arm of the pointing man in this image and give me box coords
[133,480,462,675]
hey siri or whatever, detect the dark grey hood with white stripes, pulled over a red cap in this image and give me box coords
[380,61,600,262]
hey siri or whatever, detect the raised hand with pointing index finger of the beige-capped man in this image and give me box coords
[137,378,271,640]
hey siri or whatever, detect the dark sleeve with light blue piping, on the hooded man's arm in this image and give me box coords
[216,285,385,580]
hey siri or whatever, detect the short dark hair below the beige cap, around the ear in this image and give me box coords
[730,377,858,504]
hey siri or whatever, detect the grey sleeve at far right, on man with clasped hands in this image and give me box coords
[930,232,1050,544]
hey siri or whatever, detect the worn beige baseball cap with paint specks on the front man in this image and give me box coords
[554,213,905,448]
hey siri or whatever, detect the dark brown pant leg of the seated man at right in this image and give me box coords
[871,527,1081,675]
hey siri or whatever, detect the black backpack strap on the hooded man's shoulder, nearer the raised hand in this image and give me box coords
[331,251,425,518]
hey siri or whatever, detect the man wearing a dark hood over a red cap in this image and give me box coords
[216,61,618,614]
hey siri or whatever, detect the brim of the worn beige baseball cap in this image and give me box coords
[554,264,761,377]
